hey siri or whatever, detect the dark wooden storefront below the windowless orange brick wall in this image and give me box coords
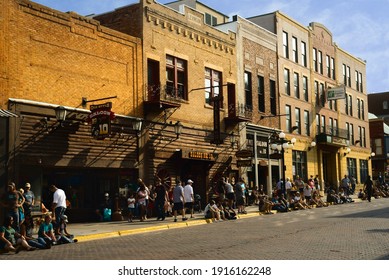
[6,99,139,222]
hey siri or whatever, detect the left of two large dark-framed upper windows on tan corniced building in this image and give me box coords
[166,55,188,100]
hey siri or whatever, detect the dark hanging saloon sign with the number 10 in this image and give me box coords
[88,102,115,140]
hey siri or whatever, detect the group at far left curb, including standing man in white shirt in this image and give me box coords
[0,183,77,254]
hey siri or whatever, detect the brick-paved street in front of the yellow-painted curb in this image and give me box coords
[0,198,389,260]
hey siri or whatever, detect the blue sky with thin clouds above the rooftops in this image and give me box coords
[33,0,389,93]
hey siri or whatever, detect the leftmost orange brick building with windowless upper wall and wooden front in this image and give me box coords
[0,0,143,221]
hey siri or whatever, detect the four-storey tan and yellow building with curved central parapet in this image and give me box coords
[249,11,371,190]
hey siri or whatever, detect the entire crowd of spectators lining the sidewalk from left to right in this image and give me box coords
[0,172,389,253]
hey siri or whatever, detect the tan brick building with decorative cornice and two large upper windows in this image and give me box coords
[94,0,239,200]
